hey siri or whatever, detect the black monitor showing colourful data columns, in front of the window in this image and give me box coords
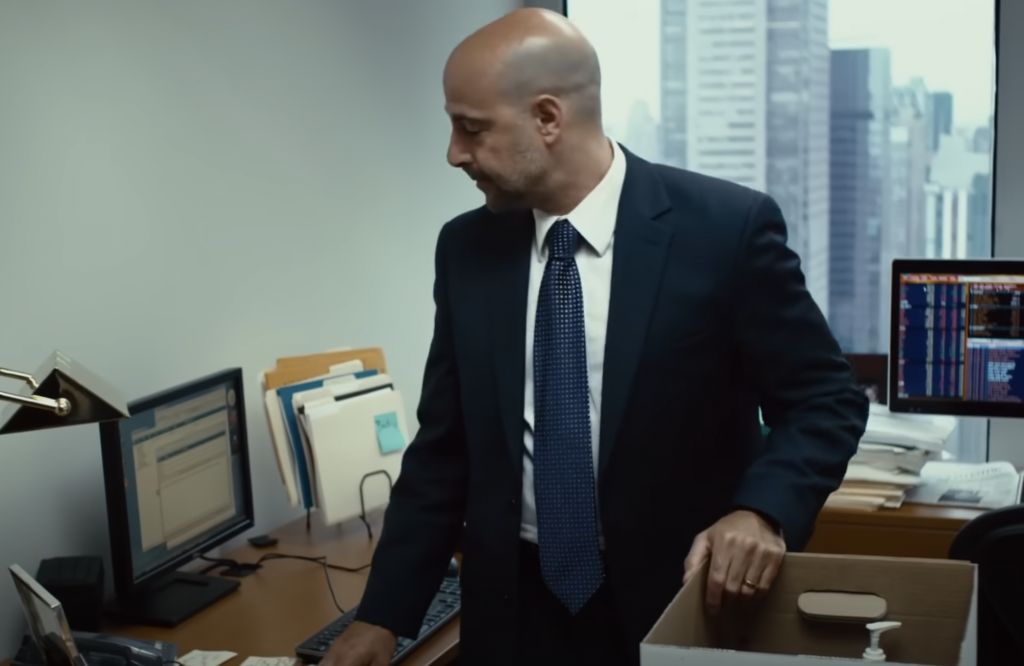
[889,259,1024,411]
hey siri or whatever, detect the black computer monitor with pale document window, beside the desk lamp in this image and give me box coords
[100,368,254,627]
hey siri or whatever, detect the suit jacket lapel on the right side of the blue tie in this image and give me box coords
[598,149,672,480]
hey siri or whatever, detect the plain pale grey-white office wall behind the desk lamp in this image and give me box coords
[0,0,518,658]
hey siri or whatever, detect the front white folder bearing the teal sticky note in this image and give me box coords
[304,380,409,525]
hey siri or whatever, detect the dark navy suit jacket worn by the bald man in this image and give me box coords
[358,146,867,664]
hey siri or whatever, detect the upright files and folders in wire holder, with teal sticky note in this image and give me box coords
[260,347,409,525]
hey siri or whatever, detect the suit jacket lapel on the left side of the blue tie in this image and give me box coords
[485,213,535,473]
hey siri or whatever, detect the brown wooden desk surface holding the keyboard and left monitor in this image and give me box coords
[34,515,459,666]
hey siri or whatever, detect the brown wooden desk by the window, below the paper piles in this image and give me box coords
[807,504,984,559]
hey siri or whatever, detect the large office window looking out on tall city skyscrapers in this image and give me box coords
[566,0,995,460]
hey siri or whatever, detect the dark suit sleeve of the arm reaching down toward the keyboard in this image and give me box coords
[357,221,468,638]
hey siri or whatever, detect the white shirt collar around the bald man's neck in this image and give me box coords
[534,140,626,261]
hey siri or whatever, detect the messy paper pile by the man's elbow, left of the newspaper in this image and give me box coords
[825,405,956,511]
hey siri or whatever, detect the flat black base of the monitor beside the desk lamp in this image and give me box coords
[103,572,240,627]
